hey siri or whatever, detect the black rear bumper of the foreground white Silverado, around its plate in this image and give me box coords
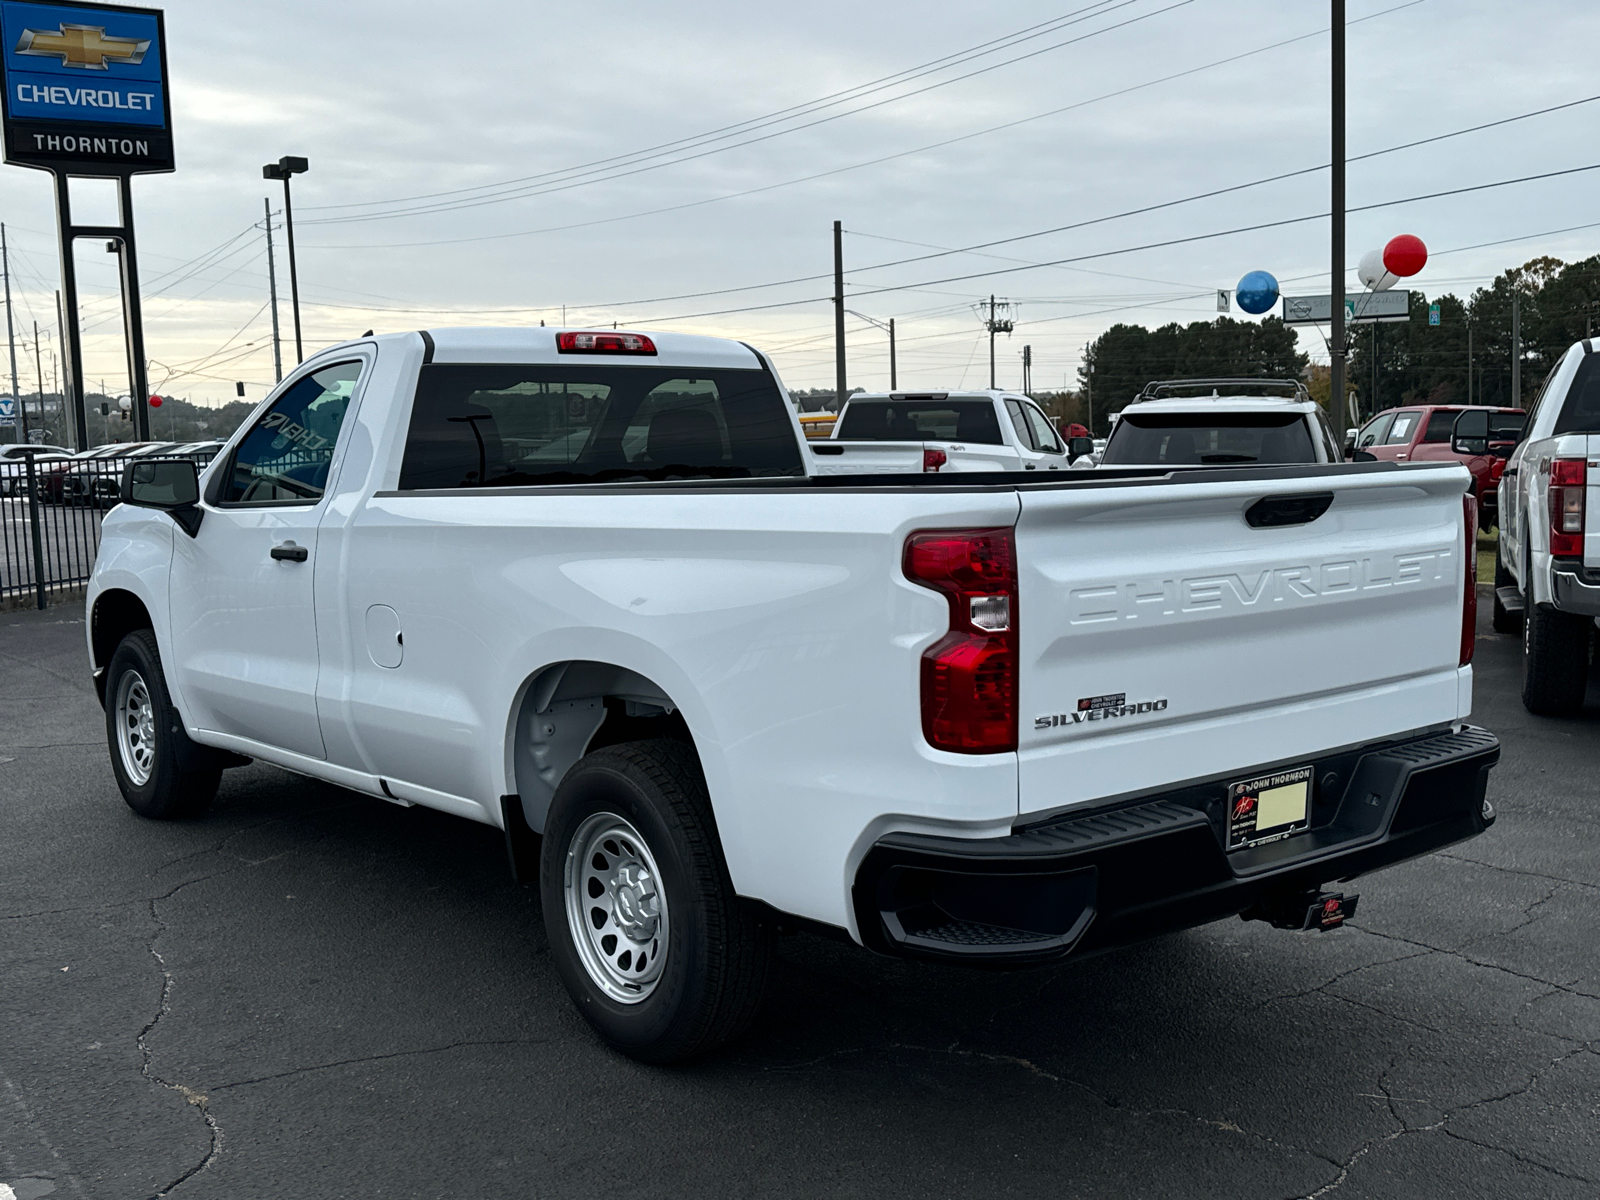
[853,726,1499,966]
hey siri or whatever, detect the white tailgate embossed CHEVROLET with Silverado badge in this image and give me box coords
[1016,464,1470,813]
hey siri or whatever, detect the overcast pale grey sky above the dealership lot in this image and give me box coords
[0,0,1600,402]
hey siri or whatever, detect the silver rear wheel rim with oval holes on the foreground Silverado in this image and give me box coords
[562,813,669,1005]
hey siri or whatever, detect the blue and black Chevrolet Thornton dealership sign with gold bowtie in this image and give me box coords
[0,0,173,174]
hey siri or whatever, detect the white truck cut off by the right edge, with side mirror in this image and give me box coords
[1491,341,1600,715]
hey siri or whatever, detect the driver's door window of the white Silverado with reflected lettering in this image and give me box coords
[218,362,362,504]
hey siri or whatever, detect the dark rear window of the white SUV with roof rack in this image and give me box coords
[1101,413,1317,467]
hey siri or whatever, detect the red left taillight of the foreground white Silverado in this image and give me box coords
[906,530,1018,754]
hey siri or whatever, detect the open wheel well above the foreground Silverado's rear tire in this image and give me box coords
[506,659,699,834]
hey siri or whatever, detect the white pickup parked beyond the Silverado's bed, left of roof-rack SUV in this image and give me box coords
[810,392,1090,475]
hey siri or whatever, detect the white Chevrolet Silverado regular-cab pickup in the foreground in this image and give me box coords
[88,328,1499,1061]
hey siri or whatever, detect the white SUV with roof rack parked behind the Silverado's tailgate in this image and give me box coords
[1094,379,1341,467]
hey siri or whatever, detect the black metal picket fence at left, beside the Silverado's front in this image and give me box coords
[0,456,123,608]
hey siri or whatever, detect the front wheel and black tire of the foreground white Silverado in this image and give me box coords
[106,629,222,821]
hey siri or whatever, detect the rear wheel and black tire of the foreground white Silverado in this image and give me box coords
[539,739,771,1064]
